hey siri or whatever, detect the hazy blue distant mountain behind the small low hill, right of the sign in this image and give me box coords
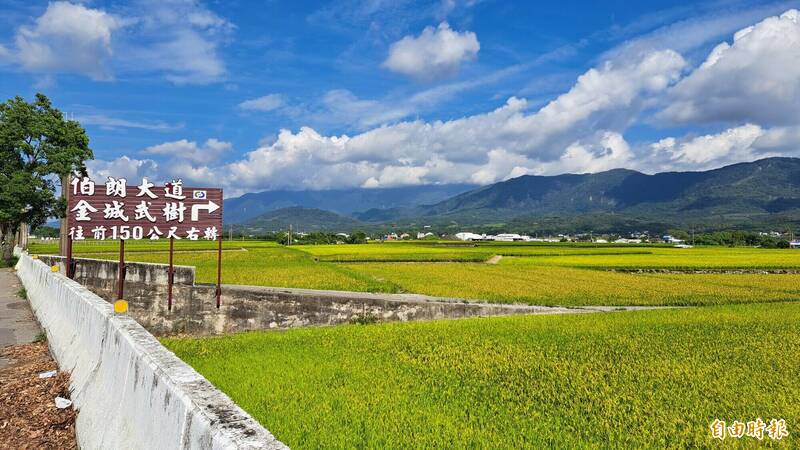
[225,184,476,224]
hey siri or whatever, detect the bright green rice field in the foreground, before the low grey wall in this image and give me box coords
[163,303,800,448]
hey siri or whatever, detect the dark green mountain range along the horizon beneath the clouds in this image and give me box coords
[225,158,800,232]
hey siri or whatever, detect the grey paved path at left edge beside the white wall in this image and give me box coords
[0,269,40,369]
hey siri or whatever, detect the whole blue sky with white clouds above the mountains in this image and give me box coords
[0,0,800,193]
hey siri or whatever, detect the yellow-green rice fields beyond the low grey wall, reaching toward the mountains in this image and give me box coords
[31,241,800,306]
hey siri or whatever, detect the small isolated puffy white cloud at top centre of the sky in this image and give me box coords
[383,22,480,81]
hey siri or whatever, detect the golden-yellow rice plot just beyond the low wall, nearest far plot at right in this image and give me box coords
[345,258,800,306]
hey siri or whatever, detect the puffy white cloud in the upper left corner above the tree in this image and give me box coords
[13,2,123,80]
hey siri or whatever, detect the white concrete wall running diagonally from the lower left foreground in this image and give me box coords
[17,253,286,450]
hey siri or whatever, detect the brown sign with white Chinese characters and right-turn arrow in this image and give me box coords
[67,177,222,241]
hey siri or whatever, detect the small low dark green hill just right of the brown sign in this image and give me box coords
[235,206,363,234]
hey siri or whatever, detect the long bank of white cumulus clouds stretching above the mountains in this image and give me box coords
[87,11,800,195]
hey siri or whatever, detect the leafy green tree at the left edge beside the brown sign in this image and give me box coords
[0,94,94,259]
